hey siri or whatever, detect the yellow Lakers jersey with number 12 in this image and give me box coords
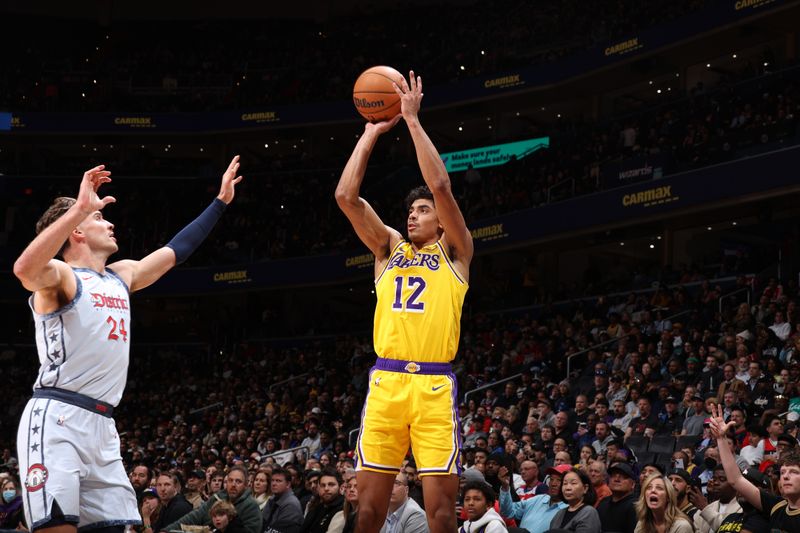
[373,241,468,363]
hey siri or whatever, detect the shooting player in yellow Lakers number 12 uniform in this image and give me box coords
[336,71,473,533]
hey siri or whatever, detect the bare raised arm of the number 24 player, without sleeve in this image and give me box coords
[14,165,116,292]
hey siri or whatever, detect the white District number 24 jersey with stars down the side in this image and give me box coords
[29,268,131,407]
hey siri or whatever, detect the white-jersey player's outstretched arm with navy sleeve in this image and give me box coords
[109,155,242,292]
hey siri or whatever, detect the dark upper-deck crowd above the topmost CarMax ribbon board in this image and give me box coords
[0,0,711,112]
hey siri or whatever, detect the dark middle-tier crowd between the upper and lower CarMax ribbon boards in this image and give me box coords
[0,58,800,274]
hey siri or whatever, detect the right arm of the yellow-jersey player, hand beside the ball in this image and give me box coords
[394,70,474,265]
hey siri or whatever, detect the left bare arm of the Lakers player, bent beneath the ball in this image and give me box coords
[336,115,401,260]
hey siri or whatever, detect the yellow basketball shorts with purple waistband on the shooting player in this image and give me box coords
[356,358,461,476]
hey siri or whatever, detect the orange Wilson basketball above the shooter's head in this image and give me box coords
[353,66,403,122]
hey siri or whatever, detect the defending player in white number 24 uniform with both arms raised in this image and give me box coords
[14,156,242,533]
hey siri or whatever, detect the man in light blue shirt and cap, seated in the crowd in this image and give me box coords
[499,465,572,533]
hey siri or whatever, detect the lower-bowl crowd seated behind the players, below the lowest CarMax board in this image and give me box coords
[0,266,800,533]
